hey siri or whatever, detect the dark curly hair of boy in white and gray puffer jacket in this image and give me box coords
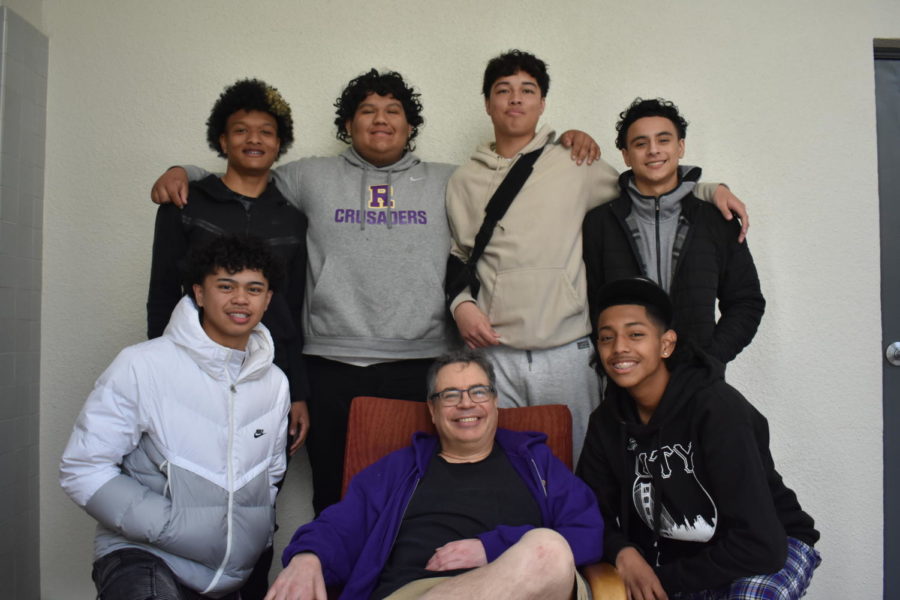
[185,234,284,298]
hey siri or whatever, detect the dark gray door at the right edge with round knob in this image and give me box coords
[875,40,900,598]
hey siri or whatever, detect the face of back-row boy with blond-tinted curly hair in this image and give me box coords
[219,110,281,175]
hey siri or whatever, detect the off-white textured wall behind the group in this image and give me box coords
[38,0,900,600]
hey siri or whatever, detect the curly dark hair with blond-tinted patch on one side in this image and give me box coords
[206,79,294,158]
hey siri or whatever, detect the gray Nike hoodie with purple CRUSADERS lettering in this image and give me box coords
[188,148,456,362]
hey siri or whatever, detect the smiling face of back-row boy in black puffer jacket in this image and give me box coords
[622,117,684,196]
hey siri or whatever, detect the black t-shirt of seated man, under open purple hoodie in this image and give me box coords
[372,444,542,599]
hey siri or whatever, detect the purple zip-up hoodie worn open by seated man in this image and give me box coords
[282,429,603,598]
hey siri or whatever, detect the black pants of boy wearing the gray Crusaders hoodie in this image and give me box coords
[306,356,434,516]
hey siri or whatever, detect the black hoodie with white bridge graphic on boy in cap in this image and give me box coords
[578,348,819,593]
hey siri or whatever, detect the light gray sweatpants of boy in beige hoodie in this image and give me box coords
[484,336,600,465]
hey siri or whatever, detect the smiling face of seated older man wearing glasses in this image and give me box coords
[428,363,500,456]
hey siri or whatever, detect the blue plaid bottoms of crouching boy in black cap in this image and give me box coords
[672,537,822,600]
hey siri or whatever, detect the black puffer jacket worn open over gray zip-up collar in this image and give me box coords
[583,168,766,363]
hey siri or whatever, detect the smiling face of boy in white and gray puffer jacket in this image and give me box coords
[193,268,272,350]
